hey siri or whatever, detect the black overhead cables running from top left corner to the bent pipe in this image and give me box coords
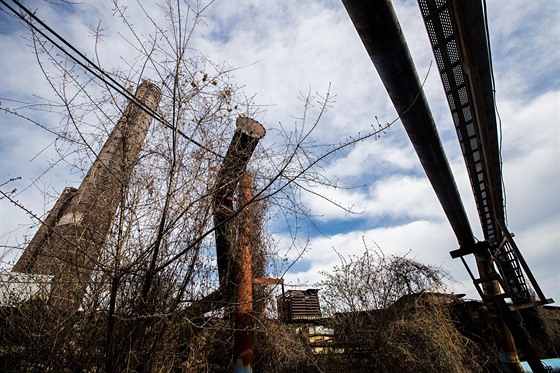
[0,0,223,158]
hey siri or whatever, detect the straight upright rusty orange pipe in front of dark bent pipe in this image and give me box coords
[233,172,254,373]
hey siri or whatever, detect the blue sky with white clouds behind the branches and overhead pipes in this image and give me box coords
[0,0,560,301]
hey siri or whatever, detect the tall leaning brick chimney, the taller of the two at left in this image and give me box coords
[15,81,161,312]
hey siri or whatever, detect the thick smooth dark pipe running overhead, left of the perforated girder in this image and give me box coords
[342,0,475,248]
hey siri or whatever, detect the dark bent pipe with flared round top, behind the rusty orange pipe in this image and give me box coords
[213,116,266,294]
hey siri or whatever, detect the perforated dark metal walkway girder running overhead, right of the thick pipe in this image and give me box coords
[418,0,538,304]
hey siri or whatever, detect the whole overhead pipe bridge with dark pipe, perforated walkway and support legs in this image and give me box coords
[342,0,552,372]
